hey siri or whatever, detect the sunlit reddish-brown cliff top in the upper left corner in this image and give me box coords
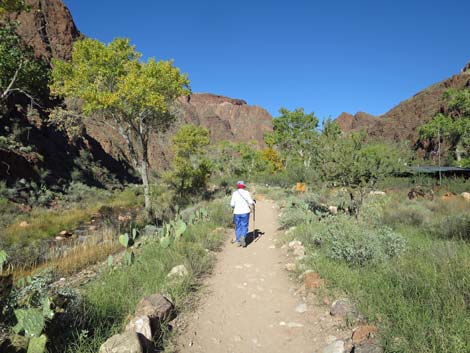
[11,0,80,61]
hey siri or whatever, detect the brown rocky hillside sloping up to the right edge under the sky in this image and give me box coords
[336,62,470,144]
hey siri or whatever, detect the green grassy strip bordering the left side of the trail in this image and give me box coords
[52,198,231,353]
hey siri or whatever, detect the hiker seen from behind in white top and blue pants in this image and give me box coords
[230,181,255,247]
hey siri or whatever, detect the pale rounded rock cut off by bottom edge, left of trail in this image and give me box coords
[99,331,152,353]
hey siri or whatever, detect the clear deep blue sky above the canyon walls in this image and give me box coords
[64,0,470,119]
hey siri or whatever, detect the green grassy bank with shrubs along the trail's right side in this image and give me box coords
[281,193,470,353]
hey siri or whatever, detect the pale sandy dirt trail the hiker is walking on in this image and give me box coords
[177,201,346,353]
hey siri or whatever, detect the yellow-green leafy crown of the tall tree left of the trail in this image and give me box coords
[51,38,189,127]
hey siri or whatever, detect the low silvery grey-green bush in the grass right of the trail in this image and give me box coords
[320,216,406,265]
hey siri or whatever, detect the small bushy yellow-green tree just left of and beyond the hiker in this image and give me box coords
[165,125,212,197]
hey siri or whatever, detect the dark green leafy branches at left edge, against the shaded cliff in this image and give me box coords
[0,21,49,105]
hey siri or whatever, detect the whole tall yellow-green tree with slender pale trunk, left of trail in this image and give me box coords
[51,38,189,212]
